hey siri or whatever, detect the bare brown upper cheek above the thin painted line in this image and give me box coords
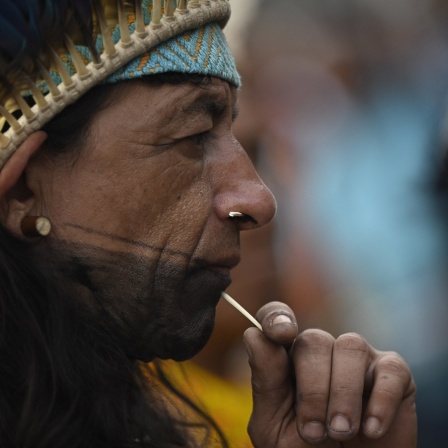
[42,160,212,250]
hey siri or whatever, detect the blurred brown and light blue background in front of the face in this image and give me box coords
[186,0,448,448]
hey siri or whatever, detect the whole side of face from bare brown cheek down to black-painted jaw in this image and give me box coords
[38,156,222,359]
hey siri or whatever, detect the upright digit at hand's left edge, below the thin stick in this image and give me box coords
[244,327,297,448]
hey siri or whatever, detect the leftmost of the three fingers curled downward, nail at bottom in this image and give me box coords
[292,330,334,444]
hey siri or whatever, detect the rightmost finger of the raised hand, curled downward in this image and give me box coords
[363,352,416,438]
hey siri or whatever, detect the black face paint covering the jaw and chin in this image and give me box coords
[53,242,230,361]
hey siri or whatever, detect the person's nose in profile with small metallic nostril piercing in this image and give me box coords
[214,142,277,230]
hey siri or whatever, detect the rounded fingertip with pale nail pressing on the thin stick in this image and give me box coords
[255,302,298,345]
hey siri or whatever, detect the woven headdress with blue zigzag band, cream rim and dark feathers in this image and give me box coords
[0,0,239,169]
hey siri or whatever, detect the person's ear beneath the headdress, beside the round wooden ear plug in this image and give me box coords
[0,131,47,237]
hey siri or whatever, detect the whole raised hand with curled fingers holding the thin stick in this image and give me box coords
[244,302,417,448]
